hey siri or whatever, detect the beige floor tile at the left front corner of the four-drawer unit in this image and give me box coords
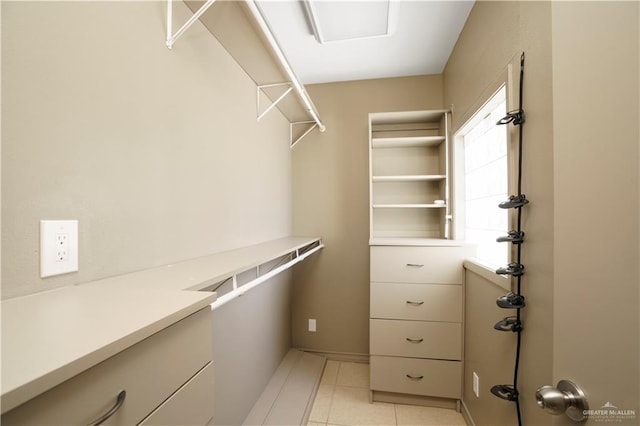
[328,386,396,426]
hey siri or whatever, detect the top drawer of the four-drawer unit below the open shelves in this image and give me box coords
[371,246,464,284]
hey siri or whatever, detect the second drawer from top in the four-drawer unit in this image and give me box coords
[370,282,462,322]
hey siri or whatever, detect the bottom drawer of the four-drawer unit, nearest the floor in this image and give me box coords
[370,356,462,399]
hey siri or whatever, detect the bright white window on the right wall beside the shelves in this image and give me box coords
[456,86,510,269]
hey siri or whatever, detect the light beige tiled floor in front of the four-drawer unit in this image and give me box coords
[308,361,466,426]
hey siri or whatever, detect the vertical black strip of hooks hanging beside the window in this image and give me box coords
[491,52,529,426]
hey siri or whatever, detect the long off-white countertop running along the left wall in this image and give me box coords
[0,237,317,413]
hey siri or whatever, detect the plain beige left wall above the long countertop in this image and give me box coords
[2,1,292,298]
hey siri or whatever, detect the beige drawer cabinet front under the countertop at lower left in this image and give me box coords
[1,307,213,426]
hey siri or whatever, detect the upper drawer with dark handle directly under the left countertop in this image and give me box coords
[2,307,212,426]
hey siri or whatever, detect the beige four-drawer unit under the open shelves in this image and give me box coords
[369,243,465,400]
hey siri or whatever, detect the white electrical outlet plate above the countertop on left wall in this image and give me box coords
[40,220,78,278]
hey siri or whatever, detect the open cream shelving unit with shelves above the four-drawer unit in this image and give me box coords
[369,110,451,244]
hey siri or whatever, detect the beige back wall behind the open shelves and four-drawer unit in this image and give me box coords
[292,76,442,355]
